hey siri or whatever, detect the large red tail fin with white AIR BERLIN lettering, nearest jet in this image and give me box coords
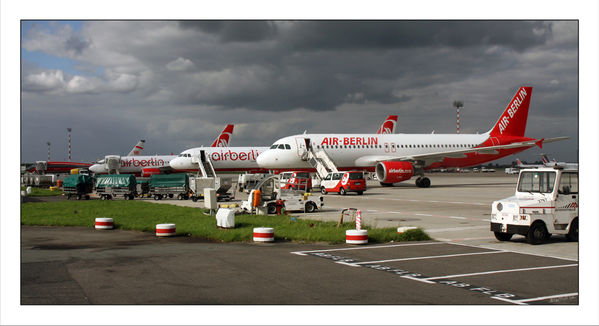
[490,86,532,137]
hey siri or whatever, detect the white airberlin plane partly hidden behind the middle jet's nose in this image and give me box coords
[89,124,233,177]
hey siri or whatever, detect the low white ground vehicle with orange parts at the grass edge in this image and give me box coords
[241,176,324,214]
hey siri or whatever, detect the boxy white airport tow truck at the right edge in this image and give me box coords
[491,166,578,244]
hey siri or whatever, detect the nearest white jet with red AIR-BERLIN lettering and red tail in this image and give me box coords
[257,87,568,188]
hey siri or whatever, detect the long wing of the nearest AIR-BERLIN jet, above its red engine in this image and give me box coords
[356,137,569,166]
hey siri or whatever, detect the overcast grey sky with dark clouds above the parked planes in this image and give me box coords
[21,20,579,163]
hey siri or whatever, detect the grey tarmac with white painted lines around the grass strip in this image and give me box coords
[21,172,579,314]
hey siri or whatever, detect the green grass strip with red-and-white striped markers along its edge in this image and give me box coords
[21,200,430,244]
